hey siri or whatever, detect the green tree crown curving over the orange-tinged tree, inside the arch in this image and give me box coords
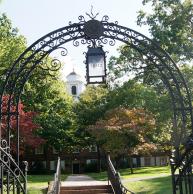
[106,80,172,143]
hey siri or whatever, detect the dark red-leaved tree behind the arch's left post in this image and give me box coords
[1,96,44,154]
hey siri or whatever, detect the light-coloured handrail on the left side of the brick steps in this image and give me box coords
[47,157,61,194]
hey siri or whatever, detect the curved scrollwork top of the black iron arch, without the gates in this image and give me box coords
[0,16,193,194]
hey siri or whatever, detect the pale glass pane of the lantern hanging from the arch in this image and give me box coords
[88,55,105,76]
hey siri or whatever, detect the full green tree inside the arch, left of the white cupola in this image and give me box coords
[23,76,76,151]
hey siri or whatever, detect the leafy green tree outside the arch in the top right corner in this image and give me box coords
[137,0,193,62]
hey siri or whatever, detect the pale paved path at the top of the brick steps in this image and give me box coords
[61,174,108,186]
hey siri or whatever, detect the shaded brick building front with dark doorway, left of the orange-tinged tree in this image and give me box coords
[25,145,98,174]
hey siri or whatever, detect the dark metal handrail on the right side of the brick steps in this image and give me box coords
[107,154,134,194]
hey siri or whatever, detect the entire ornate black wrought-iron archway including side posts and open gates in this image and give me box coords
[0,13,193,193]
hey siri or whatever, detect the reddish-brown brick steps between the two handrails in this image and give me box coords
[60,185,113,194]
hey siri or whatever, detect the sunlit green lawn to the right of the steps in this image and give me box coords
[88,166,172,194]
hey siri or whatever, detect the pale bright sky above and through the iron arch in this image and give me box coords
[0,0,150,80]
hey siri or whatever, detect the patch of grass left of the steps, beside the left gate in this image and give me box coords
[28,174,67,194]
